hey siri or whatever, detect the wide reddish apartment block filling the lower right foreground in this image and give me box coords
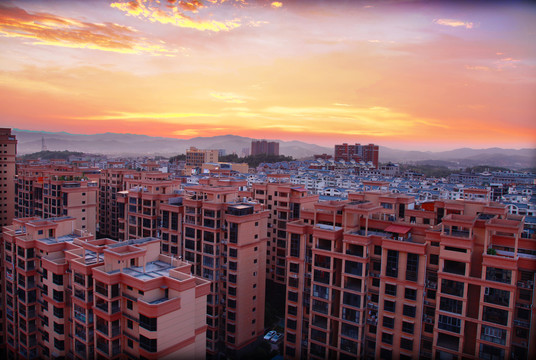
[284,183,536,359]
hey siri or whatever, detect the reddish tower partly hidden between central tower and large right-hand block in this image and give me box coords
[251,174,318,285]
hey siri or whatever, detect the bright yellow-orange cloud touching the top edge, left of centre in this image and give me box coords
[110,0,244,32]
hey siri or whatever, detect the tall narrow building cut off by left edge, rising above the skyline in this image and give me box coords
[0,128,17,232]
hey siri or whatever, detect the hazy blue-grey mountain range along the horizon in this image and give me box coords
[13,129,536,169]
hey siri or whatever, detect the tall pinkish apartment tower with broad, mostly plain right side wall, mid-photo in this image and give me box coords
[178,184,268,357]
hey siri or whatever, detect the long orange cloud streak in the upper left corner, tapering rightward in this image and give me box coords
[0,5,175,55]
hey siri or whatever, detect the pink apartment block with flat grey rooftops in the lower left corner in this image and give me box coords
[1,217,210,359]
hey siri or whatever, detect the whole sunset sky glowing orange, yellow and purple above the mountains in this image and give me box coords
[0,0,536,151]
